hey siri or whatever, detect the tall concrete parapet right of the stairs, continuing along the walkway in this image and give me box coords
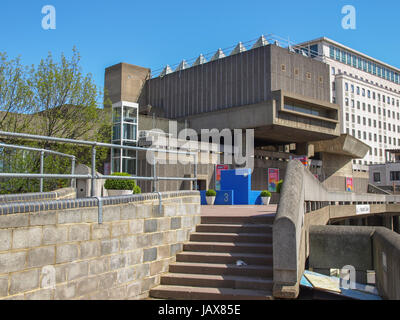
[273,160,400,298]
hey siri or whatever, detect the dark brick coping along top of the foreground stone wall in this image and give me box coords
[0,190,200,215]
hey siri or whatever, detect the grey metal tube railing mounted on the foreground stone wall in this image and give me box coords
[0,131,198,196]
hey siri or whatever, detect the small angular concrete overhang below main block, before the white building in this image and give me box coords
[311,134,371,159]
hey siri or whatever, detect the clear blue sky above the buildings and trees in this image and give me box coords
[0,0,400,94]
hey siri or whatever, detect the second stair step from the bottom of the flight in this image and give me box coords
[161,273,273,291]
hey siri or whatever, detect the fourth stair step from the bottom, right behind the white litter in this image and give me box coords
[176,251,272,265]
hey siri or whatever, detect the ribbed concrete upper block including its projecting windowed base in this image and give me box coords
[141,45,339,142]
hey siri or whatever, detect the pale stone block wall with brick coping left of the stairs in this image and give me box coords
[0,191,200,300]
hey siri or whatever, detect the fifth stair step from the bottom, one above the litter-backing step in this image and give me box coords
[183,242,272,254]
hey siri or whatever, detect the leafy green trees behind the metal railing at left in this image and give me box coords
[0,48,111,193]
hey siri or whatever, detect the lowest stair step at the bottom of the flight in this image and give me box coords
[150,285,273,300]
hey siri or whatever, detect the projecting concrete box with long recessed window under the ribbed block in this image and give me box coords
[181,90,340,143]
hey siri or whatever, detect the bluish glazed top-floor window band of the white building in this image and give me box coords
[329,46,400,84]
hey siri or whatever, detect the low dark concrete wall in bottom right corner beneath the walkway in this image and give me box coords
[309,226,400,300]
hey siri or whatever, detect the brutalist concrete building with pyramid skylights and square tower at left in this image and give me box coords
[105,37,369,192]
